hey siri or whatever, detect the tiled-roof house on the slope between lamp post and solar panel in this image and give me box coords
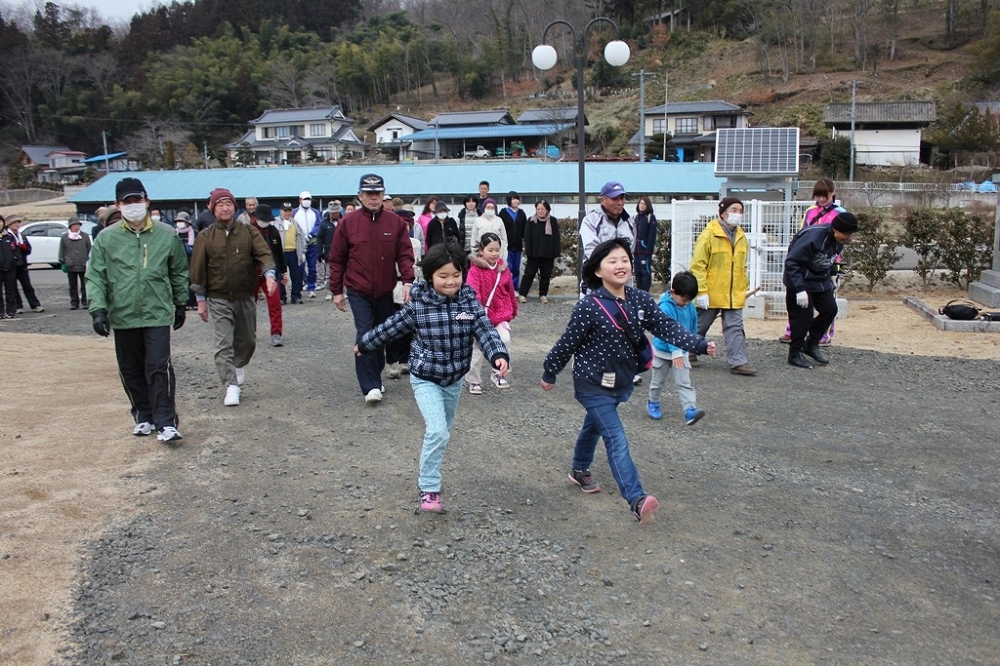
[628,99,750,162]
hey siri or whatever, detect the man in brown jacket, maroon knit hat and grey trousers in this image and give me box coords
[191,188,278,407]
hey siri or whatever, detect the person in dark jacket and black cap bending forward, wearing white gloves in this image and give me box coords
[781,212,858,370]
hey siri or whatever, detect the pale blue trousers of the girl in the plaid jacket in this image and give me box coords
[410,374,462,493]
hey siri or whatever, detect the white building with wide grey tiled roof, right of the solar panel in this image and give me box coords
[823,102,937,166]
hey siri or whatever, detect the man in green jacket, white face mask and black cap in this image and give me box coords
[87,178,188,442]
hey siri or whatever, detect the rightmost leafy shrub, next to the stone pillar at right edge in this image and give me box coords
[938,208,995,289]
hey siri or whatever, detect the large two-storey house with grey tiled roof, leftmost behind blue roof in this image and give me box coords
[226,106,366,165]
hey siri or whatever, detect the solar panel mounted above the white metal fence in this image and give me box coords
[715,127,799,175]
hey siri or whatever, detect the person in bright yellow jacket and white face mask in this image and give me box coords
[691,197,757,377]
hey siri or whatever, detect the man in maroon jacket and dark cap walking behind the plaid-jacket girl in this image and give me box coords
[329,173,414,403]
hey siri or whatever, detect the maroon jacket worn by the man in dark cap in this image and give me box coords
[327,207,413,298]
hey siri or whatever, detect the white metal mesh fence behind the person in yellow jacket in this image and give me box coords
[670,200,813,316]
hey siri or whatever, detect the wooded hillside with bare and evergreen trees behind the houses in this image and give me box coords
[0,0,1000,174]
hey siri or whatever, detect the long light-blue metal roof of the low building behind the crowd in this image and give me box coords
[69,159,725,213]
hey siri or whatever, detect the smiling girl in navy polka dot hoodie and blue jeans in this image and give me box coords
[542,238,715,524]
